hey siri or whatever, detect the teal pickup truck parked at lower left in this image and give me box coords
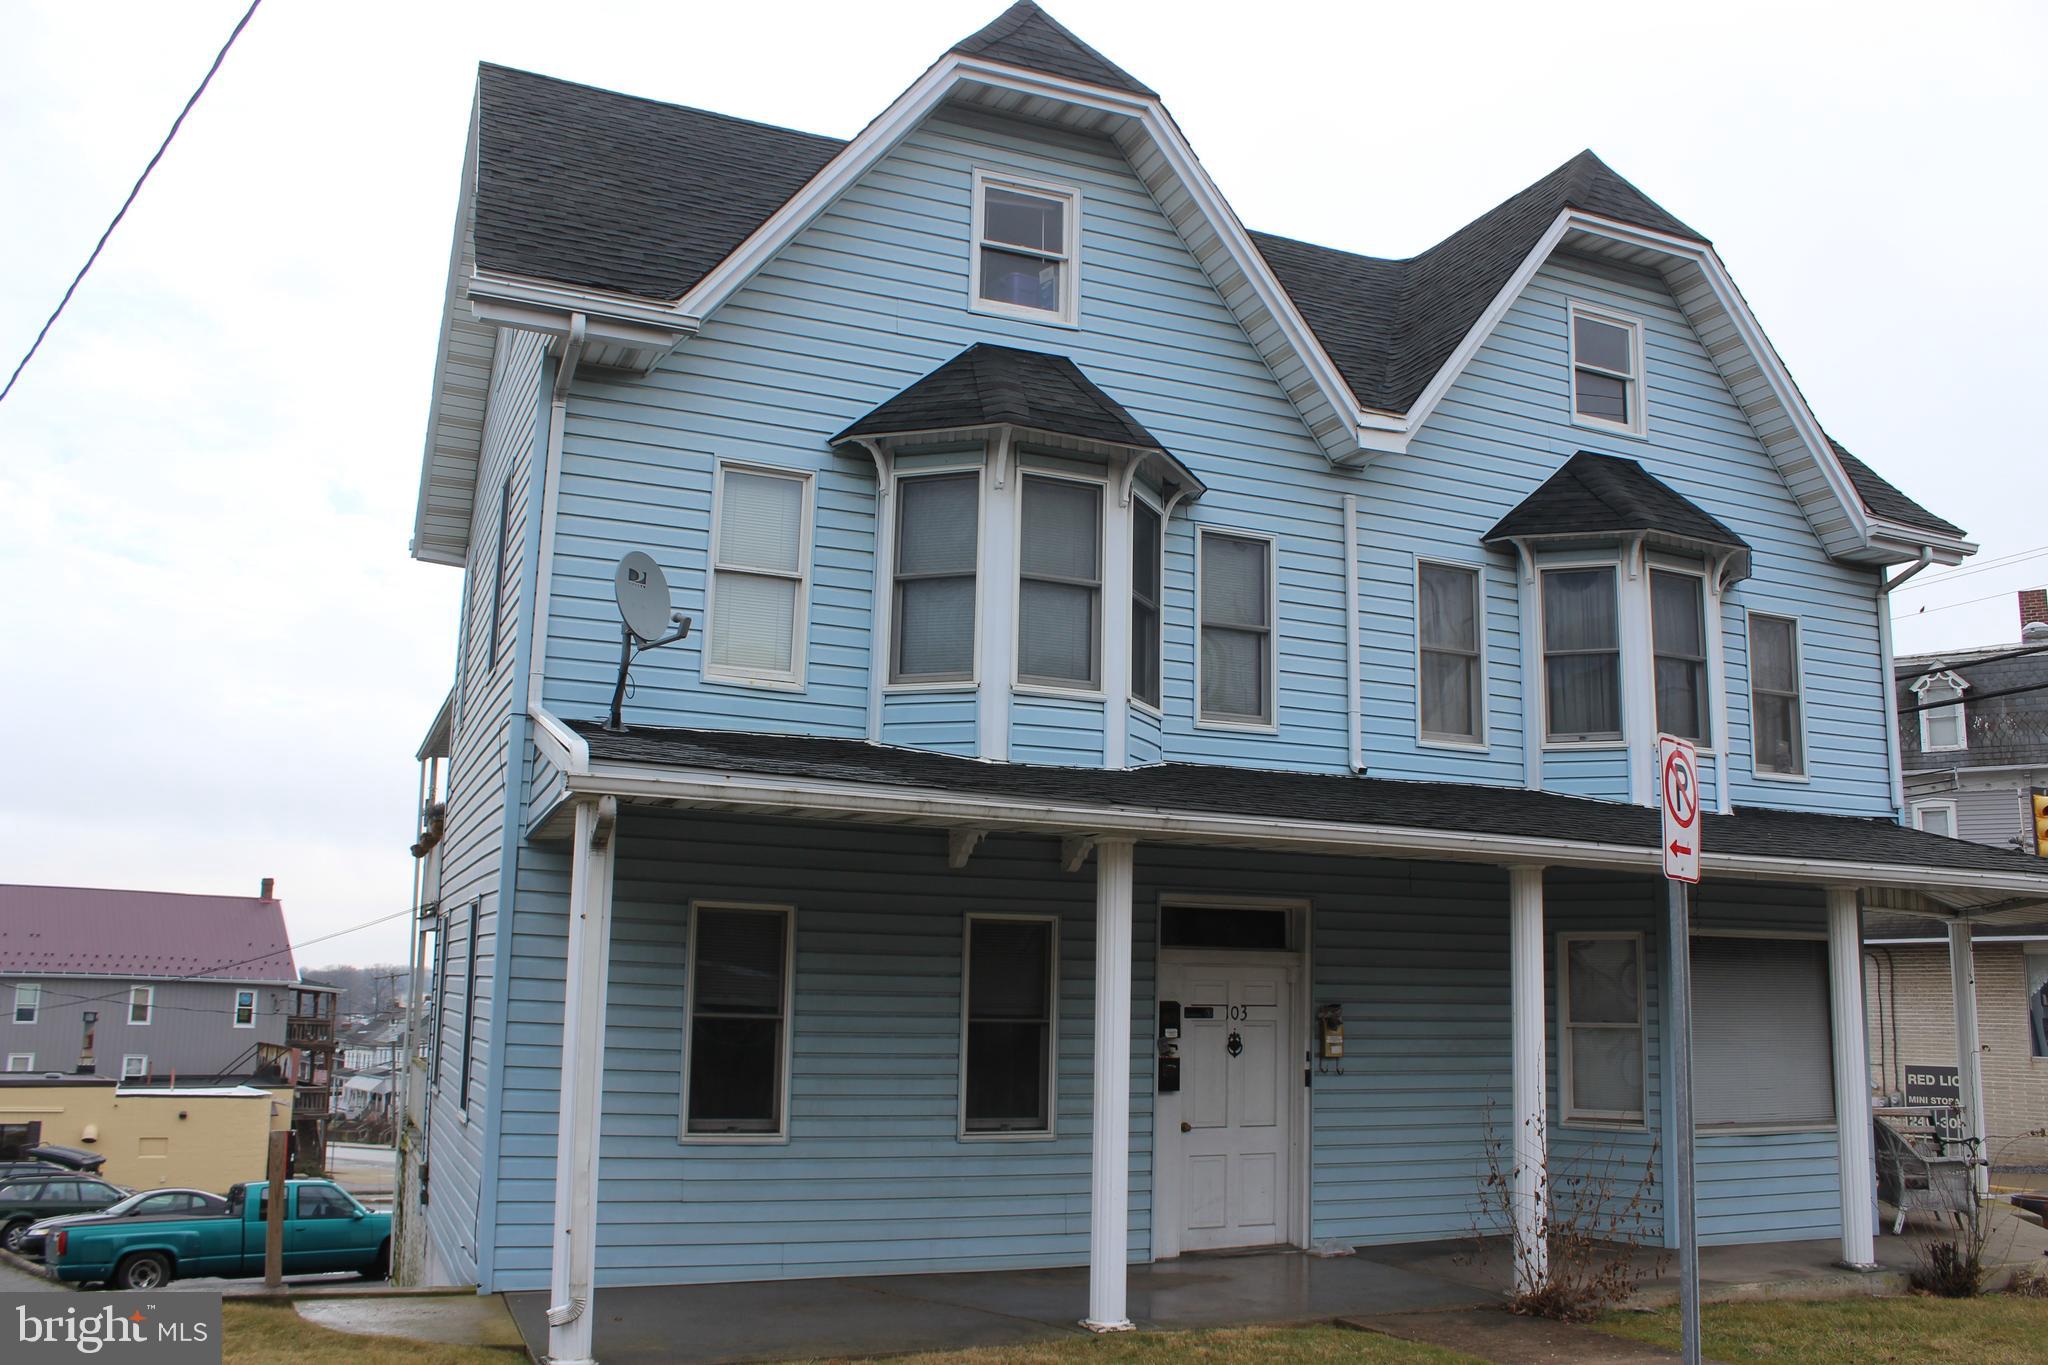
[43,1181,391,1289]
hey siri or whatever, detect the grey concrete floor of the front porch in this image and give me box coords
[506,1220,2048,1365]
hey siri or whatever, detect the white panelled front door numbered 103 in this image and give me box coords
[1159,958,1294,1250]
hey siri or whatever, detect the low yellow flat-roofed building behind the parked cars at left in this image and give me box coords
[0,1076,291,1193]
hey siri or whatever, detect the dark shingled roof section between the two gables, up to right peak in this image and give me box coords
[1251,151,1706,411]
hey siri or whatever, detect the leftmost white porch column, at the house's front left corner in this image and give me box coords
[547,796,618,1365]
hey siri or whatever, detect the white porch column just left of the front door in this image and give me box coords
[1081,839,1133,1332]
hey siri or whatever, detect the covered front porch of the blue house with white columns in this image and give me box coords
[520,716,2048,1361]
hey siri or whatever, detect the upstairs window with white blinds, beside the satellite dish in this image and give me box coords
[705,460,811,688]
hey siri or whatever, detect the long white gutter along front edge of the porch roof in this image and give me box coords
[569,763,2048,907]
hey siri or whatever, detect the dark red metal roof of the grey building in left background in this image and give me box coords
[0,886,299,980]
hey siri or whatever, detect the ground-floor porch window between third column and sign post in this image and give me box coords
[1556,933,1645,1124]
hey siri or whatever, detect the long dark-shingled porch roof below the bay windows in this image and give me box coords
[569,720,2048,879]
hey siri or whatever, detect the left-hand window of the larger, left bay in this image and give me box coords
[889,469,981,684]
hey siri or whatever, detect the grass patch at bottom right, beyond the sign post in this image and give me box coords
[1593,1295,2048,1365]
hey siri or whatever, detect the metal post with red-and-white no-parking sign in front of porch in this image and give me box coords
[1657,735,1700,1365]
